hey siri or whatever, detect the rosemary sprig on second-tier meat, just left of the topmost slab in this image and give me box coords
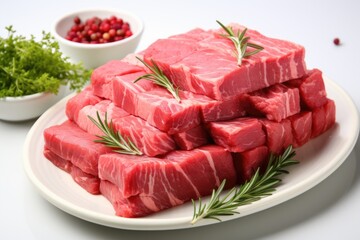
[134,57,181,102]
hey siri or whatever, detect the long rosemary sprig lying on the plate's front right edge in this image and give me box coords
[191,146,298,224]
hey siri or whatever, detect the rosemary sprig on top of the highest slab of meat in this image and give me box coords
[216,20,264,66]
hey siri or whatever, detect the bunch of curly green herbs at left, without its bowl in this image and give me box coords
[0,26,91,98]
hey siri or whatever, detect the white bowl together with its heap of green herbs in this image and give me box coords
[0,26,91,121]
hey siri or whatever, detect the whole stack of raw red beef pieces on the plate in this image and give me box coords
[44,24,335,217]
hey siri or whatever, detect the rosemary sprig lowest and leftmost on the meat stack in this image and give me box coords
[88,112,143,155]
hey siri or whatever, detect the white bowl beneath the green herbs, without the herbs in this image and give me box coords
[0,86,67,122]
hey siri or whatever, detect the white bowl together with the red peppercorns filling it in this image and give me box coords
[53,9,144,68]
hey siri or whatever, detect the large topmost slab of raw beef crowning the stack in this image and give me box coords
[144,24,306,100]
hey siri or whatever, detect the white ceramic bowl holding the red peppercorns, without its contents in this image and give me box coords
[53,9,144,68]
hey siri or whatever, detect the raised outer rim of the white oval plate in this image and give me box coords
[23,76,360,230]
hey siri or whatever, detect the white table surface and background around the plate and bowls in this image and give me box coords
[0,0,360,240]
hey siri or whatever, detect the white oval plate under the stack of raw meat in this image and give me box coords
[23,79,359,230]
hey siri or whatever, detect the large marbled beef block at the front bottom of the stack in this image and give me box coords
[99,145,236,217]
